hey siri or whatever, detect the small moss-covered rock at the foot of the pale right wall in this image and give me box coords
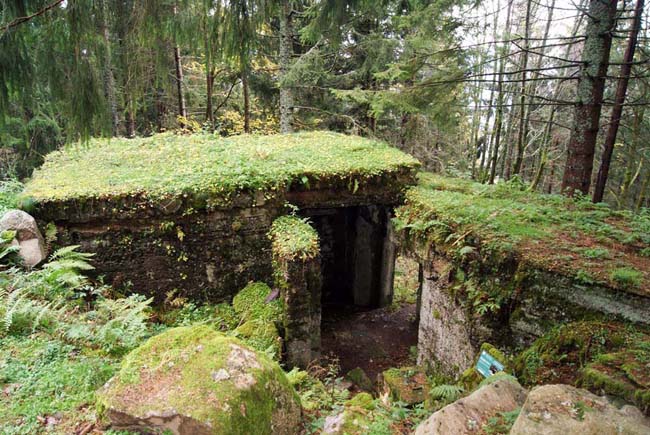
[379,367,429,405]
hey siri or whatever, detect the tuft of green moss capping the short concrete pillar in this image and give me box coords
[269,216,319,260]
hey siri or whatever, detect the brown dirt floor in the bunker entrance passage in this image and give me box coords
[321,303,418,382]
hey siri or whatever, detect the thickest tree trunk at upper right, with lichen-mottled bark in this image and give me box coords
[562,0,617,196]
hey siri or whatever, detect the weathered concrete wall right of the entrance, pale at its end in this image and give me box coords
[400,242,650,376]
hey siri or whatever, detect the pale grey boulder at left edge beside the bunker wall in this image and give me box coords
[0,210,47,267]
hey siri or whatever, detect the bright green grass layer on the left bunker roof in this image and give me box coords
[25,132,418,202]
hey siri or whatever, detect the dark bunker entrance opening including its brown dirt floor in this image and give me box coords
[303,205,418,381]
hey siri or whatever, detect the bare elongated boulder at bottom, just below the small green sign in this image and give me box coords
[415,379,526,435]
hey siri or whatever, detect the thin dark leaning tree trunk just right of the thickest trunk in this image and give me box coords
[592,0,644,202]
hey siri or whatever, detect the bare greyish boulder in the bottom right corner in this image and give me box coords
[510,385,650,435]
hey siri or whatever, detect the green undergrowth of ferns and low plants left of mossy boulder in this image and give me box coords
[0,238,152,434]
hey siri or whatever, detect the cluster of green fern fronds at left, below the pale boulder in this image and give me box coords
[0,246,152,353]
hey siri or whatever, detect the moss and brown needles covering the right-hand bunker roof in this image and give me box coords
[396,173,650,296]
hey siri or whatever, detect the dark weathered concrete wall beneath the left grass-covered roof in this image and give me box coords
[51,201,281,303]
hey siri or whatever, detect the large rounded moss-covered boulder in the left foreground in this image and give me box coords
[98,325,301,435]
